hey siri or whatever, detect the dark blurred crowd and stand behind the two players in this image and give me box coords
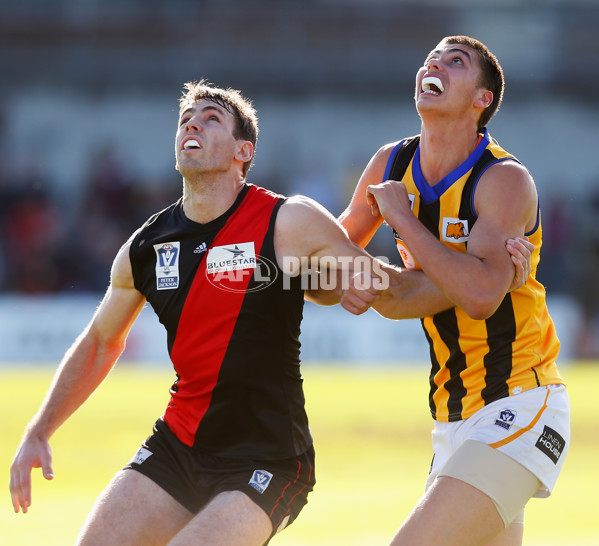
[0,0,599,358]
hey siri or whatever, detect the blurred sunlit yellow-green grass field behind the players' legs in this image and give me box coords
[0,362,599,546]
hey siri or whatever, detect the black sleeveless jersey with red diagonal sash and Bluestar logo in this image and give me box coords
[130,184,312,460]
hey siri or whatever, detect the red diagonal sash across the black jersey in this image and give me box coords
[164,186,279,446]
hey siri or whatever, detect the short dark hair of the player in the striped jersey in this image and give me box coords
[441,36,505,130]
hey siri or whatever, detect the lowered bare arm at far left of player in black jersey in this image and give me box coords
[10,240,145,513]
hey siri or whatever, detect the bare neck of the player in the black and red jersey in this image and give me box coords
[183,175,244,224]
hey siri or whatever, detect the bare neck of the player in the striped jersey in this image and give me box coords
[420,121,478,186]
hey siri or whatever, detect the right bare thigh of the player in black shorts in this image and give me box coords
[169,491,272,546]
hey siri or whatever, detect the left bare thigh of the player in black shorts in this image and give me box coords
[76,470,193,546]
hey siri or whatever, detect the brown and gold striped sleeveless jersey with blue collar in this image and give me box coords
[384,130,564,421]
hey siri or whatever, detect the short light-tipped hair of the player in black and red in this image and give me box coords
[179,79,258,178]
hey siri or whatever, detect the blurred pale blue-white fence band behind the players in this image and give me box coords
[0,295,581,366]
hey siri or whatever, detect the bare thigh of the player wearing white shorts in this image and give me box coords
[391,476,510,546]
